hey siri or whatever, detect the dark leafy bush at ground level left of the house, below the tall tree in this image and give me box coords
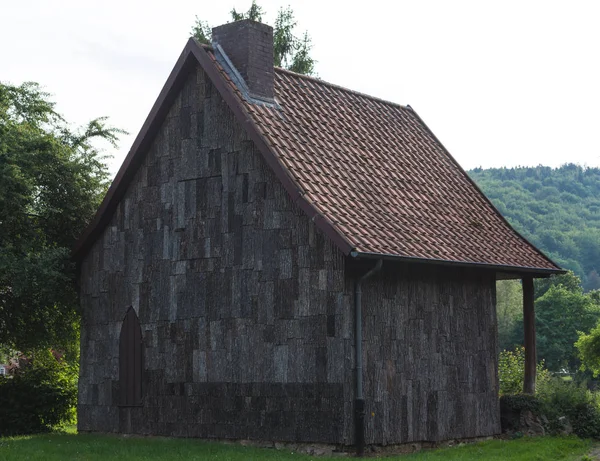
[0,350,78,436]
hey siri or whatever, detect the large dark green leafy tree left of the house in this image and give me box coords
[0,83,123,352]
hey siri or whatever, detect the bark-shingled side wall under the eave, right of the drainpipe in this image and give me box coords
[363,264,500,445]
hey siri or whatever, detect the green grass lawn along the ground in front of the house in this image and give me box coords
[0,433,591,461]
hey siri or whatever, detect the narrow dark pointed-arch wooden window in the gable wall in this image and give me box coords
[119,307,144,406]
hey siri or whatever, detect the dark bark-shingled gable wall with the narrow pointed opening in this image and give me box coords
[79,64,353,443]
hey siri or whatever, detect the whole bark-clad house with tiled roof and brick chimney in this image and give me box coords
[75,21,561,452]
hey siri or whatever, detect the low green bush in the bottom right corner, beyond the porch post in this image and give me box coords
[537,378,600,438]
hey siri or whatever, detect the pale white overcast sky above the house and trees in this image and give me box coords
[0,0,600,173]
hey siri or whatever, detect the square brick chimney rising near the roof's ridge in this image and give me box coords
[212,19,274,99]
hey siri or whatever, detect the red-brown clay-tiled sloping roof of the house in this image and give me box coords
[74,41,560,273]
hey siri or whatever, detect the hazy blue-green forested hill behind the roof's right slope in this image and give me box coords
[469,164,600,290]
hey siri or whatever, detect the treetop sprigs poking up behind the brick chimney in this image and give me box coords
[192,0,315,75]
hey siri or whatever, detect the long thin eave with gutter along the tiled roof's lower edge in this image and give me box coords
[350,251,567,278]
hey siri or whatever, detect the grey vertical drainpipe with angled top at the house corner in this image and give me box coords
[354,259,383,456]
